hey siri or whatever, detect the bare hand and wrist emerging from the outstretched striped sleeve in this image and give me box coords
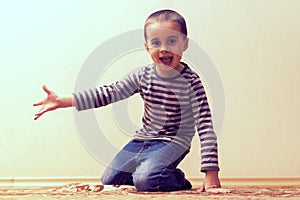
[33,85,74,120]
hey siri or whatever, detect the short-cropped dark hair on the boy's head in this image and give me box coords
[144,10,187,40]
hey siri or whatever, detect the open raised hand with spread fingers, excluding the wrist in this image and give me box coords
[33,85,59,120]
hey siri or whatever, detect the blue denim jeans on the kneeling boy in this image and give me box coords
[101,140,192,191]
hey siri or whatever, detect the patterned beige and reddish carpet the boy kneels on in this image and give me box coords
[0,183,300,200]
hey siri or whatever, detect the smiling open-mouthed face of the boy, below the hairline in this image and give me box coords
[145,22,188,73]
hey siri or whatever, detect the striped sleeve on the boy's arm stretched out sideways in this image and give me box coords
[73,67,141,111]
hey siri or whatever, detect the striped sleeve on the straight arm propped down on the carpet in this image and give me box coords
[191,77,219,172]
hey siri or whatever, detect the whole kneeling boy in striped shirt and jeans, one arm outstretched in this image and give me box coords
[34,10,221,191]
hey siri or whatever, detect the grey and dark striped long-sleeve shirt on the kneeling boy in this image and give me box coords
[73,63,219,172]
